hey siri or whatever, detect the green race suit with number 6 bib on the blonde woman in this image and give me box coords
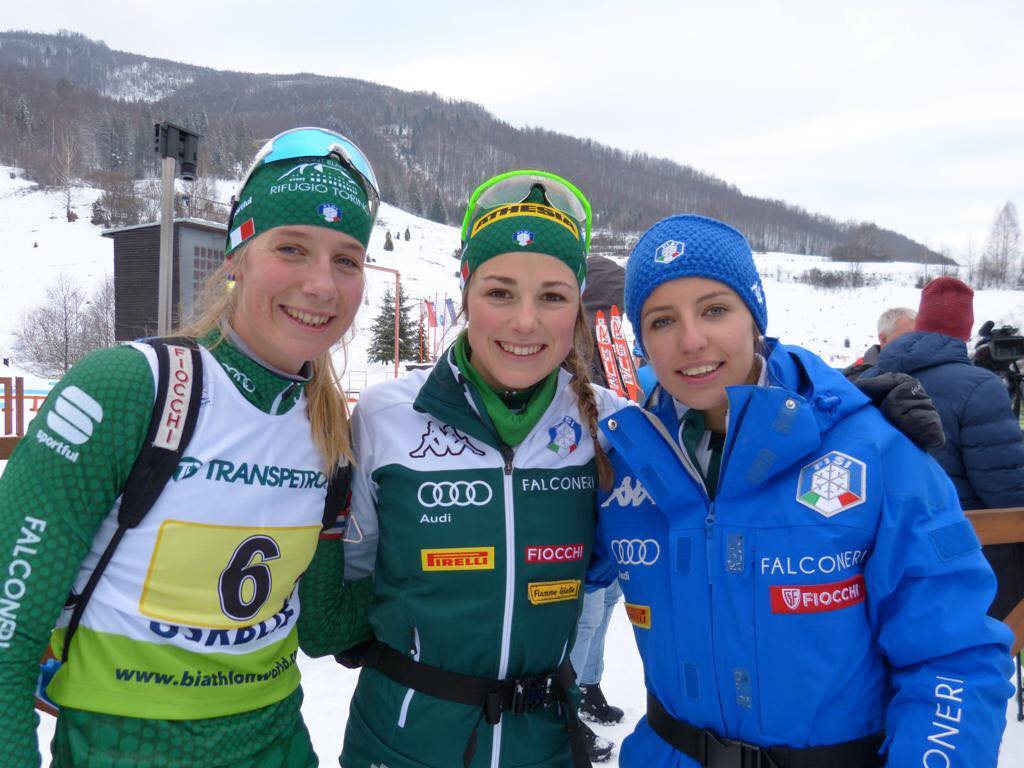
[0,340,364,768]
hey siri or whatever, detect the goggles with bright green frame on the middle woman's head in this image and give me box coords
[462,170,591,253]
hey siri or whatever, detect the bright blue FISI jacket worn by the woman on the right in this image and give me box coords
[590,340,1013,768]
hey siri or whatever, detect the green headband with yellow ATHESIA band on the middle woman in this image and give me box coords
[459,186,587,291]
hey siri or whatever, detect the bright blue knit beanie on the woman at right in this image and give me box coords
[626,213,768,357]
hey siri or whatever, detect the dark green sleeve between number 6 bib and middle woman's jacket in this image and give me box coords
[299,538,374,656]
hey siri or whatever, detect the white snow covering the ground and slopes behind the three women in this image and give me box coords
[0,167,1024,768]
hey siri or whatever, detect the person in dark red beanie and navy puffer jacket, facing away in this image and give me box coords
[874,278,1024,620]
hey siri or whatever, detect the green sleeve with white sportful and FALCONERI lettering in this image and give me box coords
[0,347,155,768]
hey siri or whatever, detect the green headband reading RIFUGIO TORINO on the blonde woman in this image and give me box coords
[224,158,373,256]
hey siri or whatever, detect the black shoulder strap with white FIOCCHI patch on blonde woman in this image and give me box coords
[60,338,203,662]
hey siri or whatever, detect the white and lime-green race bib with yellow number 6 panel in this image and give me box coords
[48,345,327,719]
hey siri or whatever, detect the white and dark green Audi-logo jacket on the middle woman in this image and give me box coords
[341,352,620,768]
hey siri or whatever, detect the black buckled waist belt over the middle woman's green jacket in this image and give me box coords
[362,641,589,768]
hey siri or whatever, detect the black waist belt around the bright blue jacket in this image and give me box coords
[647,692,885,768]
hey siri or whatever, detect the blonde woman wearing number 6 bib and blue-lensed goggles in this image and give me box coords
[0,128,379,768]
